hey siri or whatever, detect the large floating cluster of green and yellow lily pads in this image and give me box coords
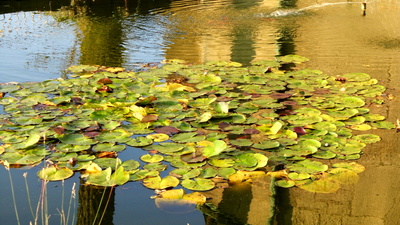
[0,56,394,198]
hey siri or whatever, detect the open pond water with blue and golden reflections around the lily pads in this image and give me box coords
[0,0,400,225]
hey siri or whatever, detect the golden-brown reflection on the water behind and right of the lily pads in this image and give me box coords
[157,0,400,225]
